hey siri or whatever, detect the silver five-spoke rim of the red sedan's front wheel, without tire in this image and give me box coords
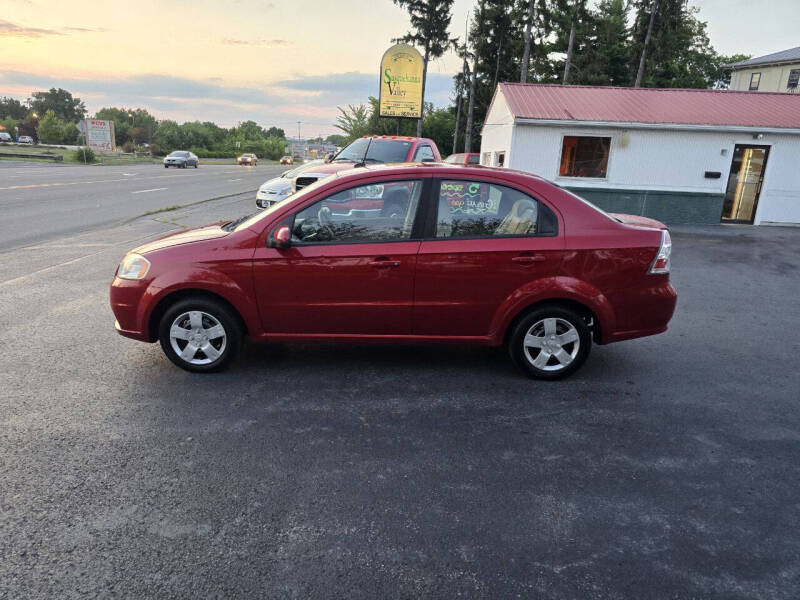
[169,310,228,365]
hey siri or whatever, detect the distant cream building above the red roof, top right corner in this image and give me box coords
[729,46,800,94]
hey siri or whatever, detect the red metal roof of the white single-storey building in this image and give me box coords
[499,83,800,129]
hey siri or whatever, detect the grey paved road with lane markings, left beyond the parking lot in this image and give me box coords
[0,161,285,250]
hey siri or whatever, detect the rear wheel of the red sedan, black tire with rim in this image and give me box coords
[508,305,592,380]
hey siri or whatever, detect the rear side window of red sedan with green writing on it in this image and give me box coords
[436,180,557,238]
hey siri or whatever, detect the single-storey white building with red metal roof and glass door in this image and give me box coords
[481,83,800,224]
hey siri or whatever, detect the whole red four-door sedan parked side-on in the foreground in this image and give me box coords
[111,164,676,379]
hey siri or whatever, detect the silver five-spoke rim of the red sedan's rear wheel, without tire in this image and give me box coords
[522,317,581,371]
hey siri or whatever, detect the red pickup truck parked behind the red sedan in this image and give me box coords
[292,135,442,191]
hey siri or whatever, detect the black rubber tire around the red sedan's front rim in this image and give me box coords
[158,297,243,373]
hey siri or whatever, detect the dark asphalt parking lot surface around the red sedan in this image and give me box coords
[0,162,800,599]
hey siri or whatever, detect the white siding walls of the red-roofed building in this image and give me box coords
[481,109,800,224]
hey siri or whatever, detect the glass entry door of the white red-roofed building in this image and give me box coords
[722,144,769,223]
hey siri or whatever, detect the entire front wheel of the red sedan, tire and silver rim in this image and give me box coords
[158,298,242,373]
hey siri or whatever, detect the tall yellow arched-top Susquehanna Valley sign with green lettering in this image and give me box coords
[378,44,422,119]
